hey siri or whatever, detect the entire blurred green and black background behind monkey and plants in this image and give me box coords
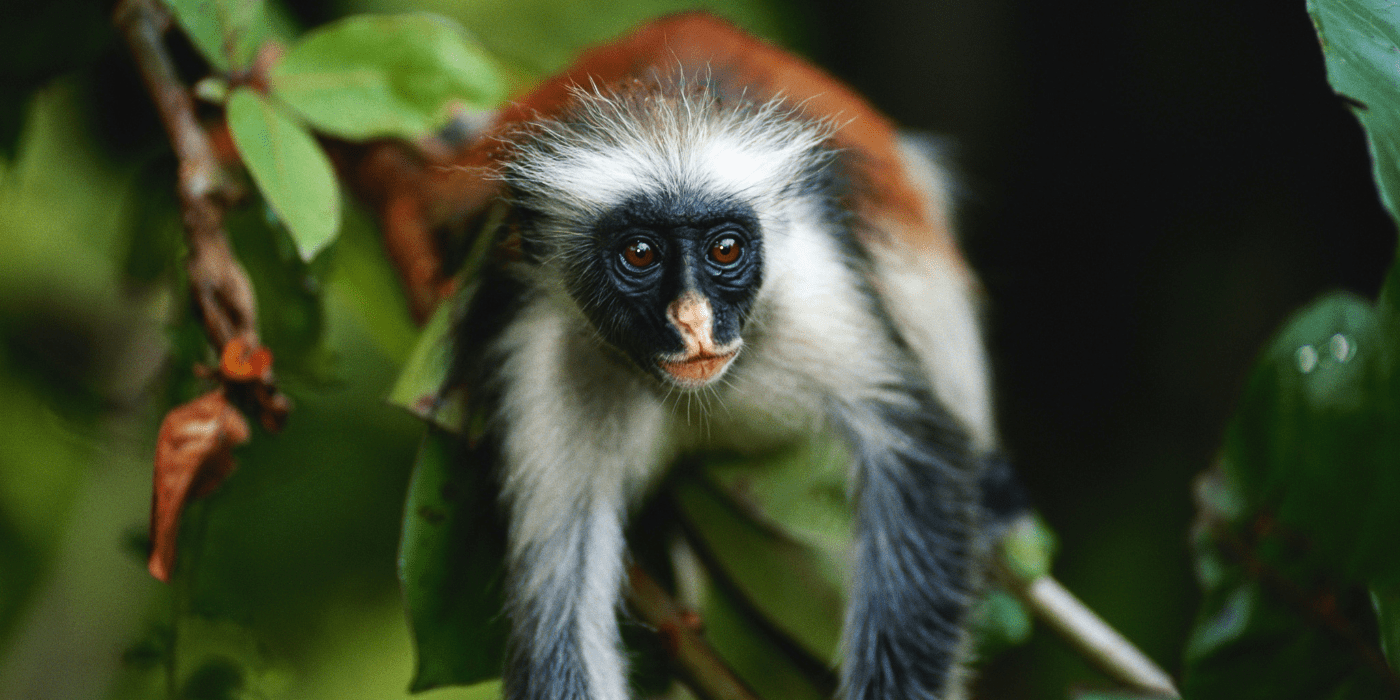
[0,0,1394,699]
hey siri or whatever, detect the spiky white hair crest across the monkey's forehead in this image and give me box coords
[503,80,836,229]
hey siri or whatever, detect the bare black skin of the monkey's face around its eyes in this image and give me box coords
[568,190,763,378]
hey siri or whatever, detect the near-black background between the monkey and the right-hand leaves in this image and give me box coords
[815,0,1394,697]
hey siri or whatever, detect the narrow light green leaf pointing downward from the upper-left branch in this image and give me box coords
[228,88,340,260]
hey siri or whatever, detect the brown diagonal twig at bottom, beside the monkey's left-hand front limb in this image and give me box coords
[627,567,757,700]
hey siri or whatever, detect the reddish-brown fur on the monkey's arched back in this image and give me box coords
[428,13,960,267]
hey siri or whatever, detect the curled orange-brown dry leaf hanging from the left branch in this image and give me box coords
[147,388,249,581]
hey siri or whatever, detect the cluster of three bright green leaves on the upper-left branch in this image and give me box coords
[168,0,504,260]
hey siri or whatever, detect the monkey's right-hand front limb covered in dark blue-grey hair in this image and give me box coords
[841,392,979,700]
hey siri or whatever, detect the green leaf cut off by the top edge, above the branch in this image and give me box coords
[164,0,273,73]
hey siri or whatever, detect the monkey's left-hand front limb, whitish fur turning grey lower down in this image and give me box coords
[487,301,665,700]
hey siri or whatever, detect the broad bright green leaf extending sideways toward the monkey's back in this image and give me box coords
[272,14,504,139]
